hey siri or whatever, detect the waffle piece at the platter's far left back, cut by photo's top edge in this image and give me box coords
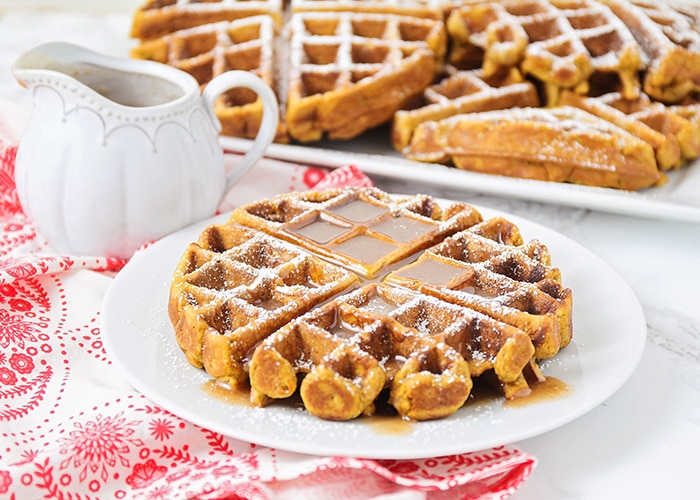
[131,0,282,40]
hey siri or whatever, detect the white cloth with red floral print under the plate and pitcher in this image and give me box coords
[0,131,536,499]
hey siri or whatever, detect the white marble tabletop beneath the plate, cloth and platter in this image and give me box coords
[0,2,700,500]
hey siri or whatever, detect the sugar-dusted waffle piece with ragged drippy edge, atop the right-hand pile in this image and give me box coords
[447,0,643,105]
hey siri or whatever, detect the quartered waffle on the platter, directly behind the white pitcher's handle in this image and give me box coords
[132,0,447,142]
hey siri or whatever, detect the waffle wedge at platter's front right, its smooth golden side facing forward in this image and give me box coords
[404,106,664,190]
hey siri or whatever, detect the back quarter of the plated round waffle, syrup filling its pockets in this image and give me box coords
[231,189,481,278]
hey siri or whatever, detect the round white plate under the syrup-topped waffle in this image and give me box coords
[101,202,646,459]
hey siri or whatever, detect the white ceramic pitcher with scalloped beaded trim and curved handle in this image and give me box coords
[12,42,278,258]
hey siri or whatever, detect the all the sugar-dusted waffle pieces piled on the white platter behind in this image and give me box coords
[132,0,700,190]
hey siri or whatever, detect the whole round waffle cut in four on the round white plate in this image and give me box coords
[169,188,572,420]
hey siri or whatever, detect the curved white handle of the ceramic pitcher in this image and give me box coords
[202,70,279,191]
